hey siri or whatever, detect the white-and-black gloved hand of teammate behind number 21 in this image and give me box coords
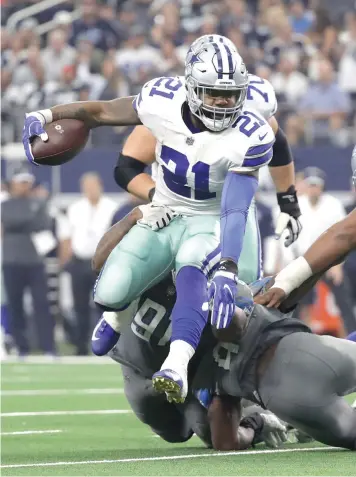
[274,186,302,247]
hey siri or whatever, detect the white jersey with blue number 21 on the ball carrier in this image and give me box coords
[134,77,275,215]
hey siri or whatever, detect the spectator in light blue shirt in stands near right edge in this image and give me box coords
[300,60,351,142]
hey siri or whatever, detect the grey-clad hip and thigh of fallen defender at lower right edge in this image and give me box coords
[259,333,356,450]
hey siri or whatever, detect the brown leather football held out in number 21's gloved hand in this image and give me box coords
[31,119,90,166]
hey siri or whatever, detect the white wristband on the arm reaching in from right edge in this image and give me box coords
[271,257,313,295]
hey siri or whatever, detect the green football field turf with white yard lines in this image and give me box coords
[1,358,356,476]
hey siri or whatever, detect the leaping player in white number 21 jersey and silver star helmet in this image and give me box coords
[23,34,284,401]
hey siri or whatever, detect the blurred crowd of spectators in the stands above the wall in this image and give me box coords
[1,0,356,146]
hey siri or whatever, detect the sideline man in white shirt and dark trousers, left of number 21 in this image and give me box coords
[68,172,117,355]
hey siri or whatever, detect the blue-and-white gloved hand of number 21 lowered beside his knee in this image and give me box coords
[208,259,237,329]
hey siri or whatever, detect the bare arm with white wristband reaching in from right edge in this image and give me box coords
[255,209,356,308]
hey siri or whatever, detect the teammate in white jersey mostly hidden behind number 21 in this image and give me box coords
[114,35,301,247]
